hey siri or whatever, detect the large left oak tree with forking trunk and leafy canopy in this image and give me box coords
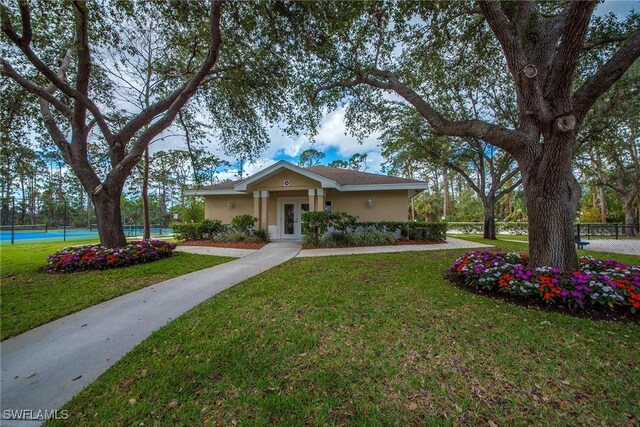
[1,0,298,247]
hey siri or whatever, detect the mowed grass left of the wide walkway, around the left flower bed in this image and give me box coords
[0,241,232,339]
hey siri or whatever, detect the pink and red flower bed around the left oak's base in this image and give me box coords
[46,240,176,272]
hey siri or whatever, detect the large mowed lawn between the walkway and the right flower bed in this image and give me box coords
[52,244,640,426]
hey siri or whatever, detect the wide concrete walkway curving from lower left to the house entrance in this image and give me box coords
[0,242,300,426]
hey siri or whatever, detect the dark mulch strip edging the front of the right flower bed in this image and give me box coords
[444,272,640,324]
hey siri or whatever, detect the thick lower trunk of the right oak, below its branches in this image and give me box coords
[520,166,580,270]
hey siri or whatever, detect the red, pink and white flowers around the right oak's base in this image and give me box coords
[449,251,640,313]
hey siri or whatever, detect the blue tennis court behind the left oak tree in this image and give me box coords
[0,227,173,245]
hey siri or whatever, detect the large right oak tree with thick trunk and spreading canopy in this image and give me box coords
[300,1,640,269]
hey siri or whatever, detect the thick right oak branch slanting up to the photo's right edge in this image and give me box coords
[573,31,640,123]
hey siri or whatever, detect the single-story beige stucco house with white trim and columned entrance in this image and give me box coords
[185,160,427,239]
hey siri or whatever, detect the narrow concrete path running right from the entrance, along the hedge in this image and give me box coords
[298,236,492,258]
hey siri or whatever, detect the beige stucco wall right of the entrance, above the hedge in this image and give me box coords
[325,189,409,222]
